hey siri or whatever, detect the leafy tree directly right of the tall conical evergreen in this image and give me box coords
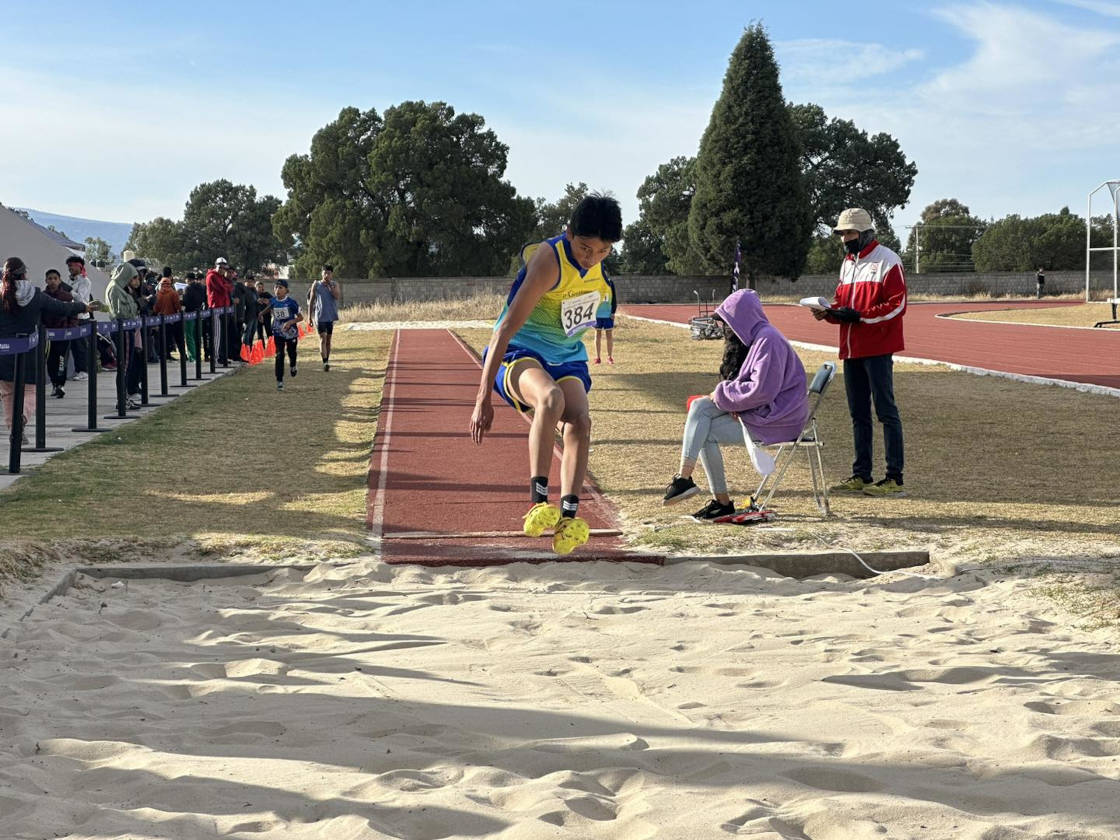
[790,104,917,238]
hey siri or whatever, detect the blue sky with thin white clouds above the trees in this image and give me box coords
[0,0,1120,241]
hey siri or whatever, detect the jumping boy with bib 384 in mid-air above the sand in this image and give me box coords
[470,193,623,554]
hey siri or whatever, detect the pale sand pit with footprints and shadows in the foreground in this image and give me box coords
[0,558,1120,840]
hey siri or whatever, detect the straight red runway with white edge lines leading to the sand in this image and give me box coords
[366,329,660,566]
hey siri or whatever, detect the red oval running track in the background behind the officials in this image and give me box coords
[622,301,1120,389]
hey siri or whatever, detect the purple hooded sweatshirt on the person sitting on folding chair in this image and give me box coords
[713,289,809,444]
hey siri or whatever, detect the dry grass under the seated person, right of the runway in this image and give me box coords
[454,318,1120,562]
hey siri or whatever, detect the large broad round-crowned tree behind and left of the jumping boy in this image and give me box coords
[273,102,535,277]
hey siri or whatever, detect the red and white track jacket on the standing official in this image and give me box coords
[830,240,906,358]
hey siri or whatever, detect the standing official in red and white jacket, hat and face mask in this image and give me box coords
[813,207,906,496]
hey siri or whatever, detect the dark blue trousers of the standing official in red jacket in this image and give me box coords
[843,353,903,484]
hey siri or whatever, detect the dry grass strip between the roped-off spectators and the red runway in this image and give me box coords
[0,330,392,591]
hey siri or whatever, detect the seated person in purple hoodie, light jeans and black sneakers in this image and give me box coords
[664,289,809,520]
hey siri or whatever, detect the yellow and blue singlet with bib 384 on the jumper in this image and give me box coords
[494,234,613,364]
